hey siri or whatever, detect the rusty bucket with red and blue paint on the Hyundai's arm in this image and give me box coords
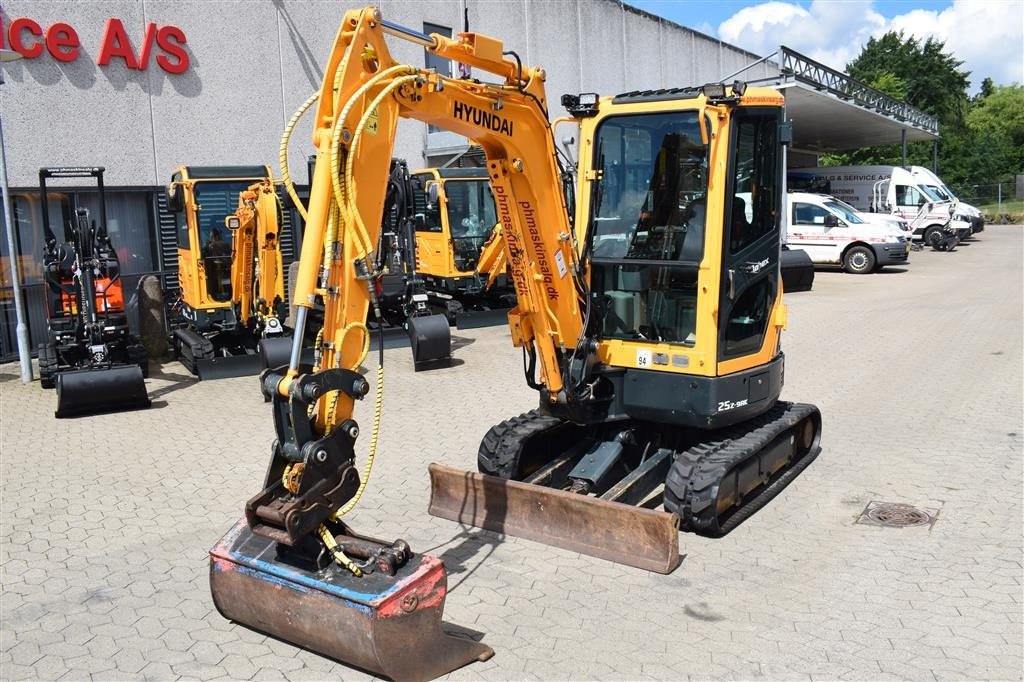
[210,519,494,680]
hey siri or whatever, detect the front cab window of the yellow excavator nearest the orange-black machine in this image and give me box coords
[195,180,252,302]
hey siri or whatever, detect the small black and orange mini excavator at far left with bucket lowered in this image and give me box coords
[39,167,151,417]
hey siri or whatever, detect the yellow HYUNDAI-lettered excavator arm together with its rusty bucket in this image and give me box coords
[211,7,584,679]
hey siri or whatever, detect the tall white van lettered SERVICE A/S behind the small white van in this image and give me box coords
[787,166,971,246]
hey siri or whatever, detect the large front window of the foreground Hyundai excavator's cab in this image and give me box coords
[588,111,708,345]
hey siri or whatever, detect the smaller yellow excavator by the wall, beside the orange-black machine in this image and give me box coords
[167,166,291,380]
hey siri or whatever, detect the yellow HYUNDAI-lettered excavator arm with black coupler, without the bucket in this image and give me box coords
[247,8,585,544]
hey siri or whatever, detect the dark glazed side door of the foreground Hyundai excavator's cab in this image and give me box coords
[718,108,781,361]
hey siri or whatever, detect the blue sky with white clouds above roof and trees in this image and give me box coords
[626,0,1024,93]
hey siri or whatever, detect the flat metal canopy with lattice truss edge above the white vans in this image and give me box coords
[765,47,939,152]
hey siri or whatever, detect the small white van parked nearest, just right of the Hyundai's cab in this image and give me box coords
[786,191,910,274]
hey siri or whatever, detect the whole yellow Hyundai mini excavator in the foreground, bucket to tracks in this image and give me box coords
[210,7,820,679]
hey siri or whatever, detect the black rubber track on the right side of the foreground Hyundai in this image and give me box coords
[665,402,820,538]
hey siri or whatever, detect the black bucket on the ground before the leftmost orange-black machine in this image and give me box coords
[53,365,152,418]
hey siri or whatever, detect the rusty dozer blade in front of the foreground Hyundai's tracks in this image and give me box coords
[428,464,679,573]
